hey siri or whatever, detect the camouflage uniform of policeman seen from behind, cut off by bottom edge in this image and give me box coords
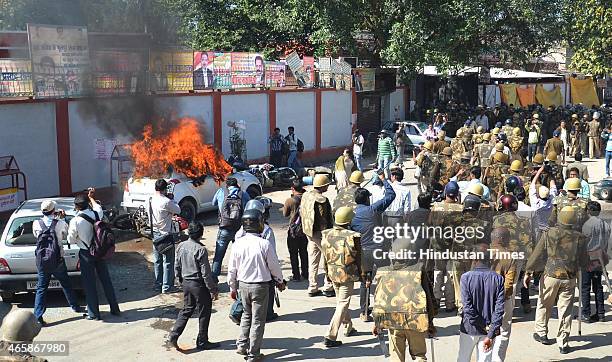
[372,263,433,362]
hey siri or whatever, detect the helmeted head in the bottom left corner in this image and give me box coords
[0,308,47,362]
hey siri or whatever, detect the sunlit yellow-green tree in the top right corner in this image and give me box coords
[564,0,612,75]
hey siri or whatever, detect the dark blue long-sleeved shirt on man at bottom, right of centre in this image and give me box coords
[459,266,504,339]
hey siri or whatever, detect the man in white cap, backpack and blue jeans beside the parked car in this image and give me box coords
[32,200,83,326]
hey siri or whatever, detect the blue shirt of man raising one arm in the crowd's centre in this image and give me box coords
[351,180,395,250]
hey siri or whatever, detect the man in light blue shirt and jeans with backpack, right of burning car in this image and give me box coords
[212,177,251,282]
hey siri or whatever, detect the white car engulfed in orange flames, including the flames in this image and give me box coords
[121,118,262,221]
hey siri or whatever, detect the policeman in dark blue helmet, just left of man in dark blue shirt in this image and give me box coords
[427,181,463,313]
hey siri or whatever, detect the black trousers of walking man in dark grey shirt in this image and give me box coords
[170,280,212,344]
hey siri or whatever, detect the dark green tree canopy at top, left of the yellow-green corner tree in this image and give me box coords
[382,0,561,78]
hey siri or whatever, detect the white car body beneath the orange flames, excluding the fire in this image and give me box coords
[121,171,262,221]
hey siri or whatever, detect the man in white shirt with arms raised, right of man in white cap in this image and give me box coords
[68,188,121,320]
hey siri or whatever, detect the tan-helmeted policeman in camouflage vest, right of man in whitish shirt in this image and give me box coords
[321,206,370,348]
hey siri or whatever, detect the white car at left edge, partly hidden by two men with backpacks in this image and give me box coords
[0,197,81,302]
